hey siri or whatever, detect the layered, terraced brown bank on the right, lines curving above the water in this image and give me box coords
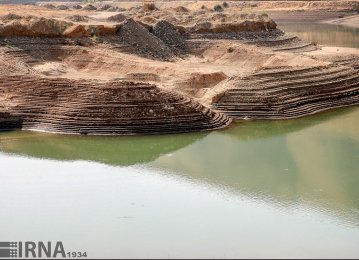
[212,65,359,119]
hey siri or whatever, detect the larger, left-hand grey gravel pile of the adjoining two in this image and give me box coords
[117,19,174,60]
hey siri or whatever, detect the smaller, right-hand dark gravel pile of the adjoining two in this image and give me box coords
[153,21,187,54]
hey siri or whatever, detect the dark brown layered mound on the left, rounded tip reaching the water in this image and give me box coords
[0,76,231,135]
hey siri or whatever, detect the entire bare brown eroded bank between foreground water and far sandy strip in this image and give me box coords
[0,2,359,135]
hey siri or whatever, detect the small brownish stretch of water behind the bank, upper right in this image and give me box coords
[278,23,359,48]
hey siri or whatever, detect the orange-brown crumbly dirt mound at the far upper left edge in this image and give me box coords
[0,16,72,37]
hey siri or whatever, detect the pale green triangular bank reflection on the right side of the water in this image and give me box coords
[153,108,359,226]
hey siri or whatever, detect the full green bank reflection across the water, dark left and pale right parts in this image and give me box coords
[0,108,359,226]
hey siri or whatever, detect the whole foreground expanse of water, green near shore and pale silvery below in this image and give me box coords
[0,107,359,258]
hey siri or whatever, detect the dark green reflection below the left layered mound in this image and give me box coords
[0,131,207,166]
